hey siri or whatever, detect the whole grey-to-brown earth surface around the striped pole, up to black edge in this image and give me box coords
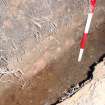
[0,0,105,105]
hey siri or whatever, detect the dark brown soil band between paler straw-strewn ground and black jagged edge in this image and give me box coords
[0,25,105,105]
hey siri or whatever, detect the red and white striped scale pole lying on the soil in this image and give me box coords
[78,0,96,62]
